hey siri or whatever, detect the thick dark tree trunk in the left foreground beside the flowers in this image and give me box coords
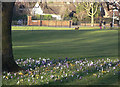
[2,2,21,72]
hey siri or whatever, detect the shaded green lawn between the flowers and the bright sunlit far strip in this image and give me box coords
[12,29,118,59]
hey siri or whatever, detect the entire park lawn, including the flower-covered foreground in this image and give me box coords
[3,27,120,85]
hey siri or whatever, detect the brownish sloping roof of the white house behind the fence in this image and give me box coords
[40,3,76,15]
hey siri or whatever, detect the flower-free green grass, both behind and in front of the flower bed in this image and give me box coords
[4,26,118,85]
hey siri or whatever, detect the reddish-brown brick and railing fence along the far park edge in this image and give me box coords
[12,16,118,27]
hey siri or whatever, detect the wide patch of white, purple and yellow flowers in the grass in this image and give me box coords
[3,57,120,85]
